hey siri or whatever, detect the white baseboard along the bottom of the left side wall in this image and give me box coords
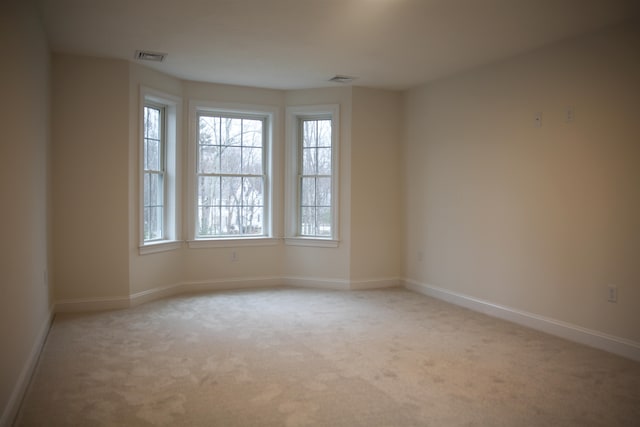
[0,307,54,427]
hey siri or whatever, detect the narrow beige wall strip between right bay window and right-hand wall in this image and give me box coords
[350,87,402,280]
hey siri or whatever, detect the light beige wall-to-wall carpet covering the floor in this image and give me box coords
[17,288,640,427]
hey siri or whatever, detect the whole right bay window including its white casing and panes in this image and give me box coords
[286,105,339,246]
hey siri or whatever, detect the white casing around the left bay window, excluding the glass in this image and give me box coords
[138,87,182,255]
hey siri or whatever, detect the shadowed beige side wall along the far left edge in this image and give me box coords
[0,1,52,426]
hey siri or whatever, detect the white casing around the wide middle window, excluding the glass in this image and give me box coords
[182,100,280,249]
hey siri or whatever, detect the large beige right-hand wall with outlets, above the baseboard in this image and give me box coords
[404,27,640,342]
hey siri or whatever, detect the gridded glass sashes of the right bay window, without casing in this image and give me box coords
[297,117,333,238]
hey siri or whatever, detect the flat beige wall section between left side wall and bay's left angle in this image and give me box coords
[52,54,129,300]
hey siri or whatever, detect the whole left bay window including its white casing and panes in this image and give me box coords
[140,88,181,254]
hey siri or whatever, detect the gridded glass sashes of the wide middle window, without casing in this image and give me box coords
[195,112,267,239]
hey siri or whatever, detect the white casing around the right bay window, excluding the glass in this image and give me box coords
[285,104,340,247]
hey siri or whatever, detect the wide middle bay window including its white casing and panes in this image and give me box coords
[187,100,278,248]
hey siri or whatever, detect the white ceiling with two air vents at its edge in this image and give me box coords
[38,0,640,89]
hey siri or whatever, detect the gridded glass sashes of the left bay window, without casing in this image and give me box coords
[142,103,166,242]
